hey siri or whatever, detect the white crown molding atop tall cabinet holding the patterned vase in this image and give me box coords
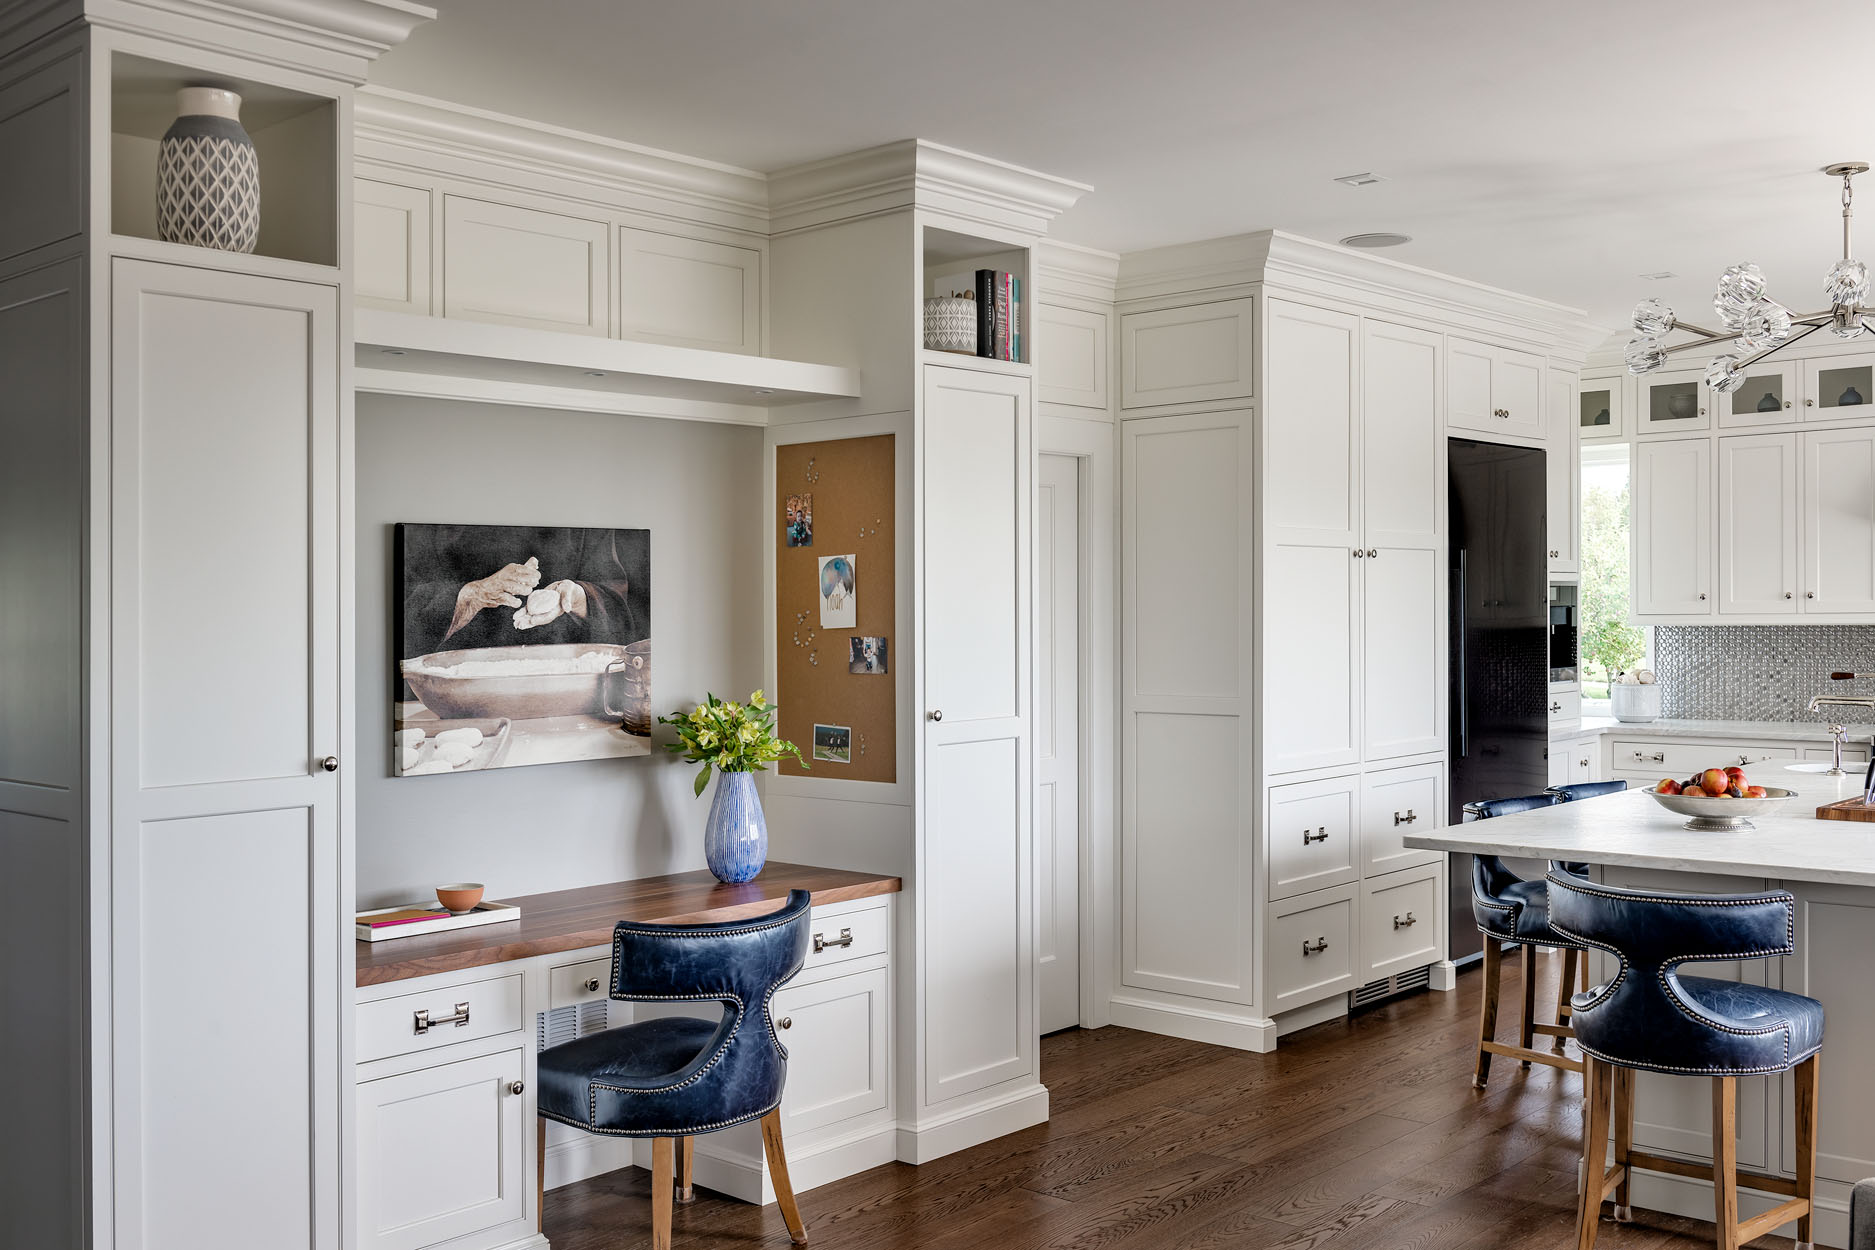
[68,0,437,84]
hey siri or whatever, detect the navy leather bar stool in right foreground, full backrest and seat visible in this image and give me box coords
[1549,870,1823,1250]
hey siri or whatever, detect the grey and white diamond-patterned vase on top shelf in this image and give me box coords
[156,86,261,251]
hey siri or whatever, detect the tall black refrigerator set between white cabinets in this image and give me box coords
[1446,439,1549,963]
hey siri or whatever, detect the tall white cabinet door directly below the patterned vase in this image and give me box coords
[109,260,353,1250]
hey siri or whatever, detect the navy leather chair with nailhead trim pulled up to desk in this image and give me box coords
[538,890,812,1250]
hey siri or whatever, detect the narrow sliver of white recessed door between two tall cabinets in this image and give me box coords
[1035,455,1080,1033]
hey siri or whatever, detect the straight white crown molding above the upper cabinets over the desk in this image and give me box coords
[353,86,769,234]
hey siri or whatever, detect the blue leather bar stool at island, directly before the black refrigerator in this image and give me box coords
[1464,791,1583,1089]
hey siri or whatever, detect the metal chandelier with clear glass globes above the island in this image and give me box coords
[1626,161,1875,395]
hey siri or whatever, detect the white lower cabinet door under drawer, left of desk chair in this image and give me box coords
[358,1048,534,1250]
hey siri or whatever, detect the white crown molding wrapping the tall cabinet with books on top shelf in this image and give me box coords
[769,139,1091,236]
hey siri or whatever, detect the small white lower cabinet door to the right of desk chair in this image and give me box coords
[774,967,891,1132]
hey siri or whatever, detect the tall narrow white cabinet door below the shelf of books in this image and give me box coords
[917,365,1037,1106]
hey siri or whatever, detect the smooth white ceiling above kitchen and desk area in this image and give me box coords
[371,0,1875,342]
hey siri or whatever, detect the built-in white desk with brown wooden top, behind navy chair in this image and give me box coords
[354,862,900,1250]
